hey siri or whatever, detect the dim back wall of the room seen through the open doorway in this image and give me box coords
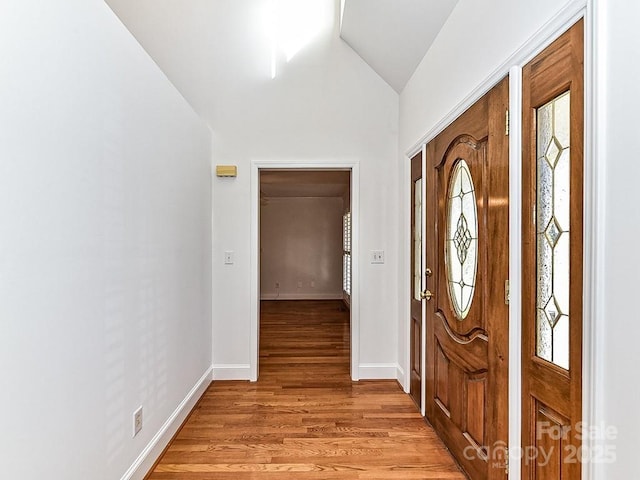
[260,197,344,300]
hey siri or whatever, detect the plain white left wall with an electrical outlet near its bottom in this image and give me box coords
[0,0,211,480]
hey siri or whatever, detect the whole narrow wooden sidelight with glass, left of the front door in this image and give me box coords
[409,149,424,410]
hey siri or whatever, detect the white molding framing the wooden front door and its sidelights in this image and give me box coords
[400,0,606,480]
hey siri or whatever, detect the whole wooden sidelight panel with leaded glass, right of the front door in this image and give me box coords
[522,21,584,480]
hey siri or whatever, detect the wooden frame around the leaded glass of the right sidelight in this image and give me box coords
[522,20,584,480]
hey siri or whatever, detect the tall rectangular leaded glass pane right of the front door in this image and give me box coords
[536,92,571,369]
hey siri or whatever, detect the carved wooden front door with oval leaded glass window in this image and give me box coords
[426,79,509,480]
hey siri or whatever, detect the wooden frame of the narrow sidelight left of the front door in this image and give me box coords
[409,151,424,409]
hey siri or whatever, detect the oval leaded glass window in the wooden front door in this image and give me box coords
[445,159,478,320]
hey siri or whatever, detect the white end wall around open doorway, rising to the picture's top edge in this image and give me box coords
[102,0,400,378]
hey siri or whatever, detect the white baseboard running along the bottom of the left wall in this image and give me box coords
[120,367,213,480]
